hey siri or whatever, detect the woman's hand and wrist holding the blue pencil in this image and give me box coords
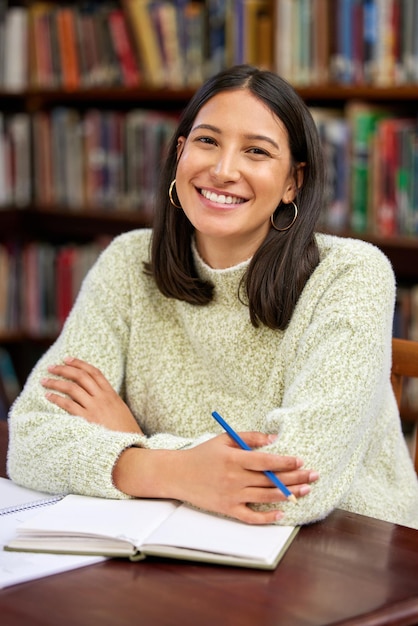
[113,432,318,524]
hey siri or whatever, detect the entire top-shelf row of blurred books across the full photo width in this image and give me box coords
[0,0,418,90]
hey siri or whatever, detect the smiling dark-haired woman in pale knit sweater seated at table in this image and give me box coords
[8,66,418,527]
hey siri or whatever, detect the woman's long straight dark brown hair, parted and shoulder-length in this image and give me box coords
[145,65,324,330]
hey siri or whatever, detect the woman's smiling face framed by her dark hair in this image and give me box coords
[176,88,303,269]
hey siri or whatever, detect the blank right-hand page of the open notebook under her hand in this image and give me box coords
[147,505,294,562]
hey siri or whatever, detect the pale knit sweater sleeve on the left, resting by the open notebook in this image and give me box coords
[8,237,196,498]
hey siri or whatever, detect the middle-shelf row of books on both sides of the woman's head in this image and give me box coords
[0,101,418,236]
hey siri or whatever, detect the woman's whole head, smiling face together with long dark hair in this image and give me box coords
[152,66,324,329]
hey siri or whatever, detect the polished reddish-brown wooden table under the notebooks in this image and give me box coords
[0,414,418,626]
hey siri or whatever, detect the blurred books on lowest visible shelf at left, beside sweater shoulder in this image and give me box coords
[0,238,109,337]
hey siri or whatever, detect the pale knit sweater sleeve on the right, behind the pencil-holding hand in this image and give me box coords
[265,244,404,524]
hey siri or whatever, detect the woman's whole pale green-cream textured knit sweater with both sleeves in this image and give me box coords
[8,230,418,528]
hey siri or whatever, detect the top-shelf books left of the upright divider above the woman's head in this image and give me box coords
[0,0,273,91]
